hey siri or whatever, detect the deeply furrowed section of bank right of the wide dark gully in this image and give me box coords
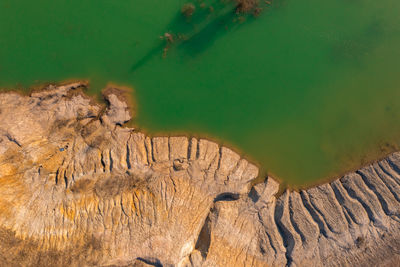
[198,170,400,266]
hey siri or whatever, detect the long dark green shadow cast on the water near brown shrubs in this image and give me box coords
[130,1,262,72]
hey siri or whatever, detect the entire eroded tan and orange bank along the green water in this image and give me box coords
[0,83,400,266]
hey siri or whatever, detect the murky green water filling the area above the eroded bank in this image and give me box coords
[0,0,400,185]
